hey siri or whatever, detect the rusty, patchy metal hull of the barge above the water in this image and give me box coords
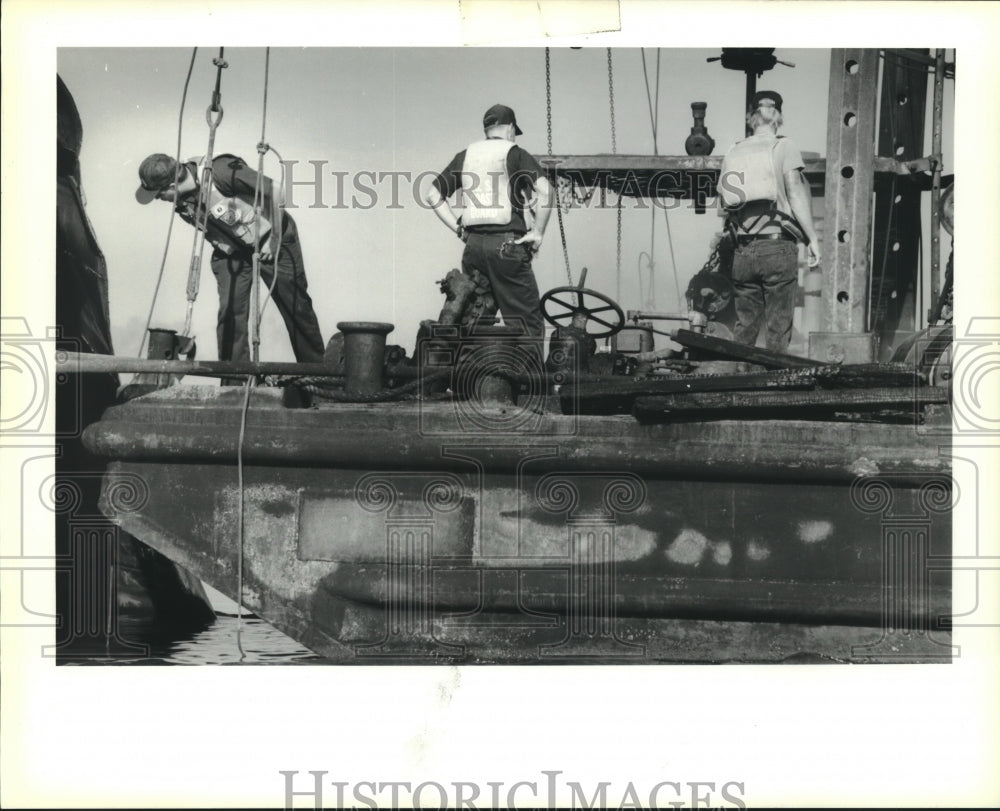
[85,387,951,664]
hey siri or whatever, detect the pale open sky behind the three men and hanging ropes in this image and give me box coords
[58,47,916,360]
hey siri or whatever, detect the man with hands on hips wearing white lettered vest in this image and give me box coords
[424,104,552,339]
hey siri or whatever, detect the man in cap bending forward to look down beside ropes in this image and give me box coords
[135,154,325,372]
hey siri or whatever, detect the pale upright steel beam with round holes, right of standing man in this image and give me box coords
[822,48,878,333]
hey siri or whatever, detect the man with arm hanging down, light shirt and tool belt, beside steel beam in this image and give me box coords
[718,90,820,352]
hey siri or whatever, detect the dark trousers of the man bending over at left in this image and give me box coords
[212,228,326,363]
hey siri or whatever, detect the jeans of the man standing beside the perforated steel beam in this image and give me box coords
[733,239,799,352]
